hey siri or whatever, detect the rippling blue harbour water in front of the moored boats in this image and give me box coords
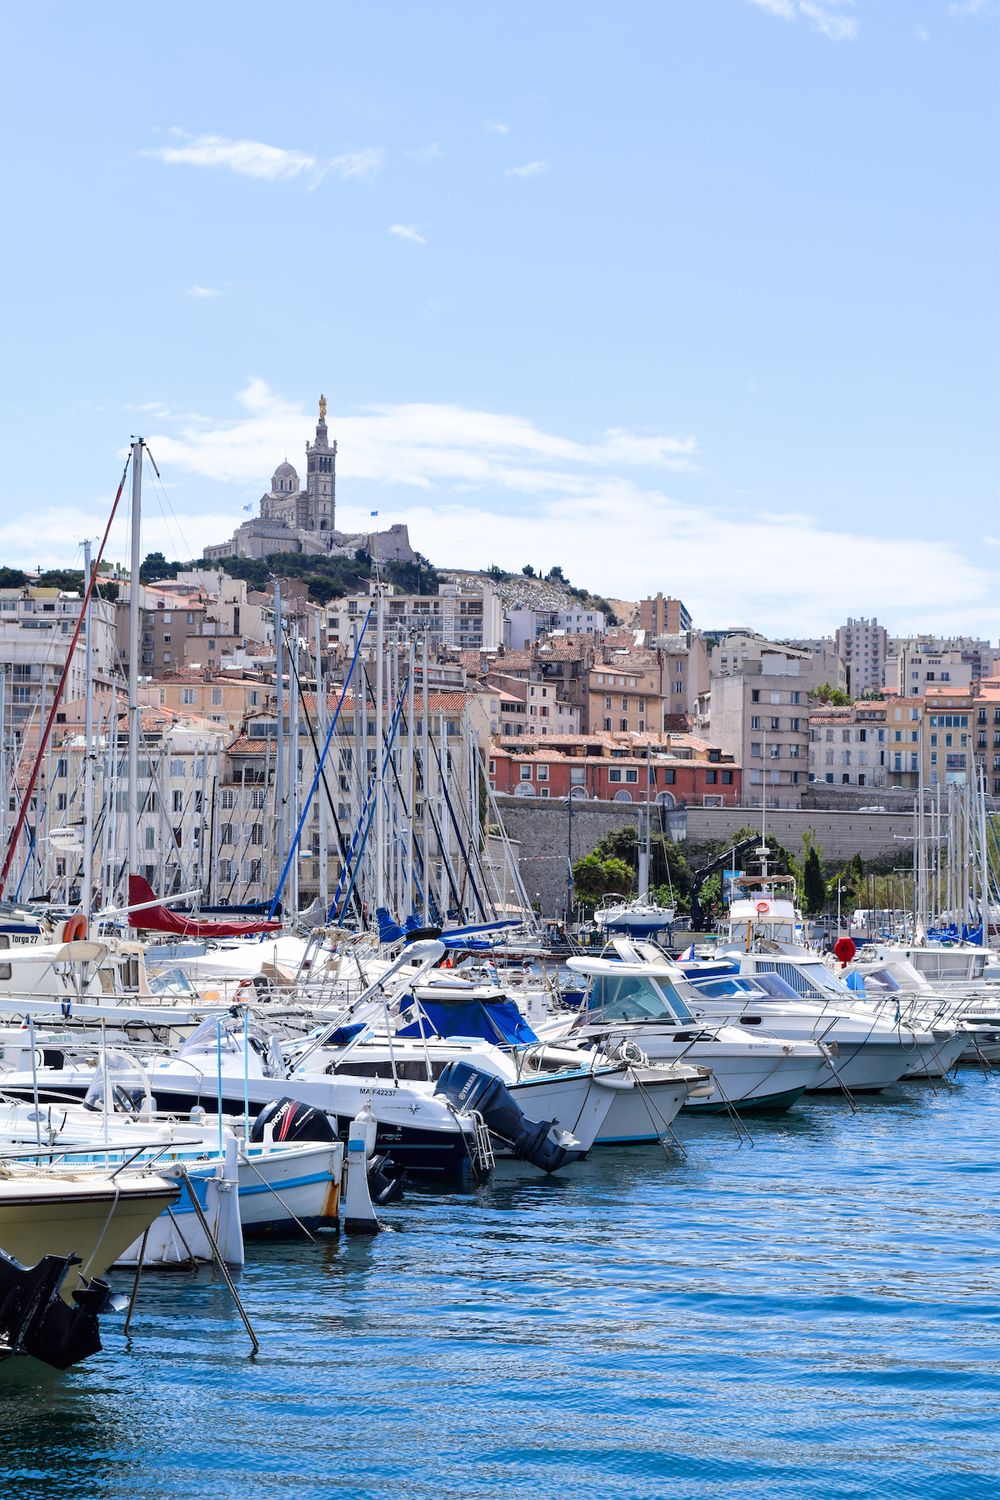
[7,1070,1000,1500]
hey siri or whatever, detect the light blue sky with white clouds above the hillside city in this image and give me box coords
[0,0,1000,638]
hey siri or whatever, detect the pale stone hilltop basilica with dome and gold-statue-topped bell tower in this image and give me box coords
[205,396,415,563]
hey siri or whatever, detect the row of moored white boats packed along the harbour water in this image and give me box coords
[0,875,1000,1365]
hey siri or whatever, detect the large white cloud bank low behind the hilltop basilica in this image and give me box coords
[137,380,1000,635]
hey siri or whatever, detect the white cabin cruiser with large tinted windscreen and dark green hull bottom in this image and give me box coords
[540,950,826,1112]
